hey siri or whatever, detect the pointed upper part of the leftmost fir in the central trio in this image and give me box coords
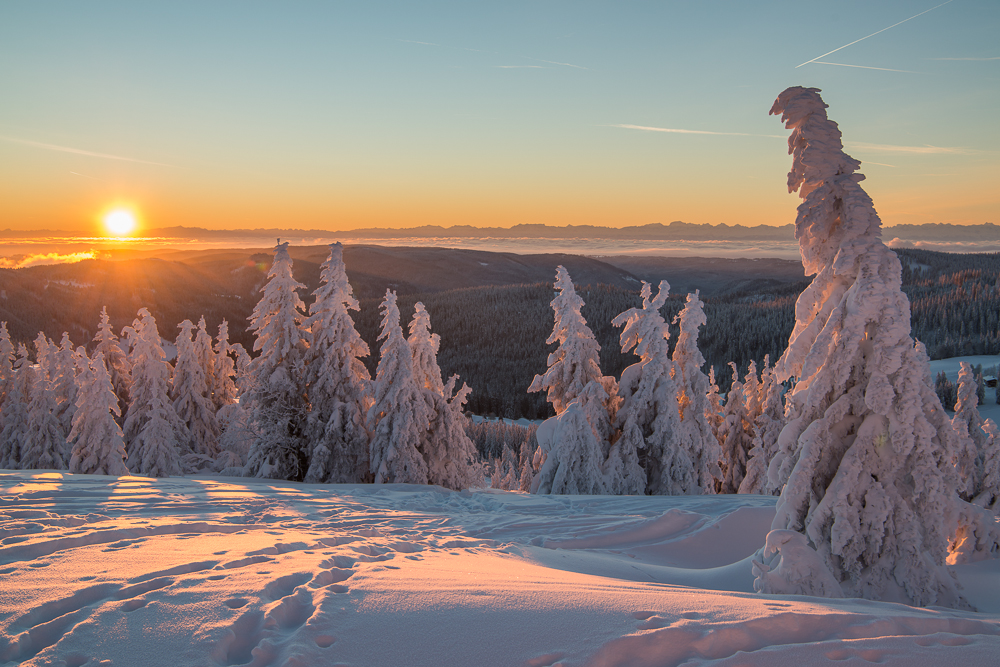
[528,266,616,415]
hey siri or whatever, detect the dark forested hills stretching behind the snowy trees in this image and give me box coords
[0,246,1000,418]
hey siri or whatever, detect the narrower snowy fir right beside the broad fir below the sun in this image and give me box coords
[172,318,220,468]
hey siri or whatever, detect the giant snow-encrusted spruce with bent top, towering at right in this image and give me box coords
[754,87,966,606]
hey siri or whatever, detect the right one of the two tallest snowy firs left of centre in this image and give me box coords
[305,243,372,484]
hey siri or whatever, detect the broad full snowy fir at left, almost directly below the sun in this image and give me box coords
[122,308,191,477]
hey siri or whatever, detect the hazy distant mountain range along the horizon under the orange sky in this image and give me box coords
[7,220,1000,242]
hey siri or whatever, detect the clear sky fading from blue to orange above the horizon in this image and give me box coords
[0,0,1000,232]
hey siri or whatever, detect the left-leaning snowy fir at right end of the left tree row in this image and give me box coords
[406,301,483,490]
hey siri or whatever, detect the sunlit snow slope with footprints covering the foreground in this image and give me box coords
[0,471,1000,667]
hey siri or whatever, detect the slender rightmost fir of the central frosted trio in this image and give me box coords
[671,291,722,494]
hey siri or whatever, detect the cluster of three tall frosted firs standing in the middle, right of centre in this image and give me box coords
[529,267,722,495]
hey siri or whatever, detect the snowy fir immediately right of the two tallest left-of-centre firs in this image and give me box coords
[368,290,431,484]
